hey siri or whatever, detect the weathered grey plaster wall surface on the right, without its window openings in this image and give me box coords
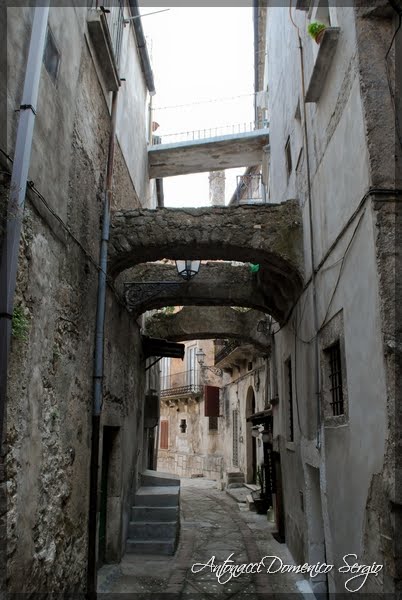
[267,7,393,592]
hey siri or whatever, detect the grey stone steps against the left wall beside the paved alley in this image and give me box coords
[126,470,180,555]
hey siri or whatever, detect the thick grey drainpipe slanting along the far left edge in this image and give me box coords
[0,1,49,443]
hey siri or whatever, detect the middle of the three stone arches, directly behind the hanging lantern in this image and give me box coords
[121,262,300,322]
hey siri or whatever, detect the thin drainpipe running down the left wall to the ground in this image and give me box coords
[87,91,117,598]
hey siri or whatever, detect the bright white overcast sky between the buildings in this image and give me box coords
[141,6,254,207]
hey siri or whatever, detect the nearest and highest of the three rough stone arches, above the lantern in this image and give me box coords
[109,200,303,284]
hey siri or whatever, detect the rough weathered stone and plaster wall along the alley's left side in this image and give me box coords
[6,8,149,592]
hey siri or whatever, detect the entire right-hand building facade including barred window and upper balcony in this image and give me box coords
[257,2,400,593]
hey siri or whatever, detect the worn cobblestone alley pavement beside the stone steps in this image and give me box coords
[98,478,302,598]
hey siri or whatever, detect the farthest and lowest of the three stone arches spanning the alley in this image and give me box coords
[145,306,270,352]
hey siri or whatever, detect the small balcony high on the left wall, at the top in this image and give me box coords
[87,0,124,92]
